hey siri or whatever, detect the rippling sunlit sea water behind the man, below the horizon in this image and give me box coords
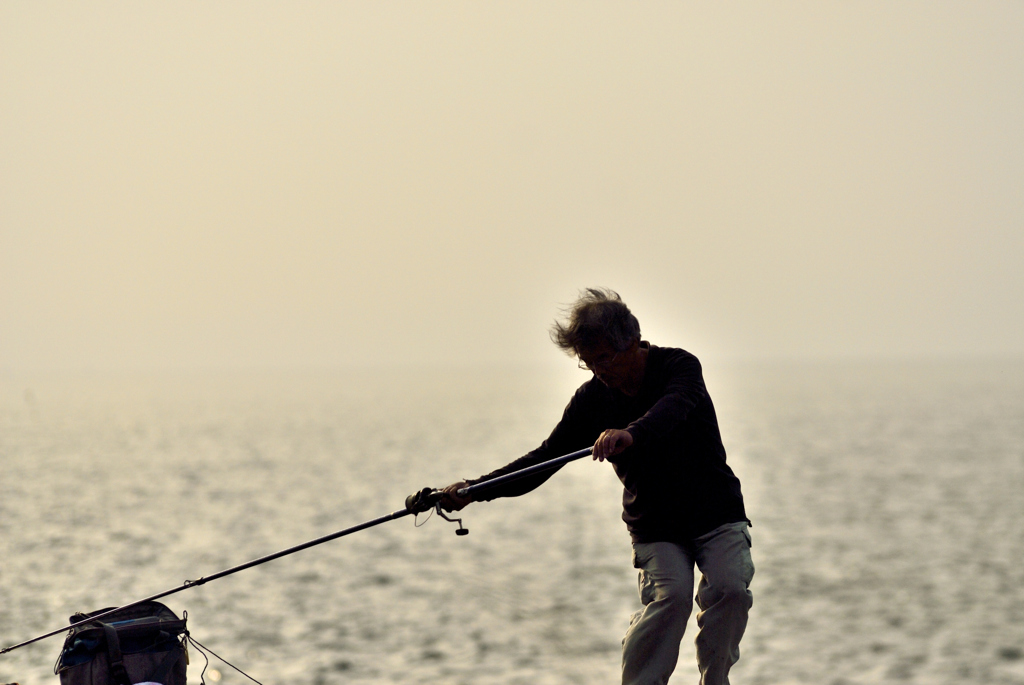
[0,361,1024,685]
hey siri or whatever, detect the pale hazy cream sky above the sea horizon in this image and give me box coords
[0,0,1024,370]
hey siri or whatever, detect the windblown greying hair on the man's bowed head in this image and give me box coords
[551,288,640,354]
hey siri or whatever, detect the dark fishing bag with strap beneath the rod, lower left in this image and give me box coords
[53,602,188,685]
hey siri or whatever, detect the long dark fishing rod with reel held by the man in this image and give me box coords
[0,447,593,654]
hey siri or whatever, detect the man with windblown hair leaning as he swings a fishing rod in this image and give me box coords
[441,289,754,685]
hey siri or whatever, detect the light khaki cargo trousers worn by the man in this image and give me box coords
[623,521,754,685]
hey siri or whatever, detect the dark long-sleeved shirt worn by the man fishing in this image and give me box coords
[470,343,748,544]
